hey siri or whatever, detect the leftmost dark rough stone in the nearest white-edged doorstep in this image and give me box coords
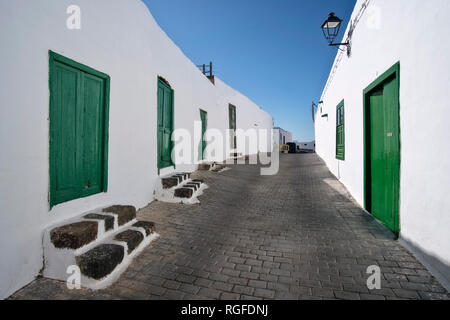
[50,221,98,249]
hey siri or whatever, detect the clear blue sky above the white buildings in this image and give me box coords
[143,0,356,141]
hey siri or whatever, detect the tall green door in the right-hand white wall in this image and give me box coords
[366,65,400,233]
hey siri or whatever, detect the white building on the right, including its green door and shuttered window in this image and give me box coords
[315,0,450,288]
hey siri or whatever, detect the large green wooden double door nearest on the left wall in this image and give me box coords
[50,53,109,206]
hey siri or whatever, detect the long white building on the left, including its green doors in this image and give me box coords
[0,0,273,298]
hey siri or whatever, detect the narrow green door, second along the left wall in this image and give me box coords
[158,79,173,169]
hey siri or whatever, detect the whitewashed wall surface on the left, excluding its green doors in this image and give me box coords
[0,0,272,298]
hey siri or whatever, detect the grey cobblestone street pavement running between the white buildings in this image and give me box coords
[11,154,449,300]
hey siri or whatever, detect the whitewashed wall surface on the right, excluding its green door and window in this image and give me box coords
[315,0,450,286]
